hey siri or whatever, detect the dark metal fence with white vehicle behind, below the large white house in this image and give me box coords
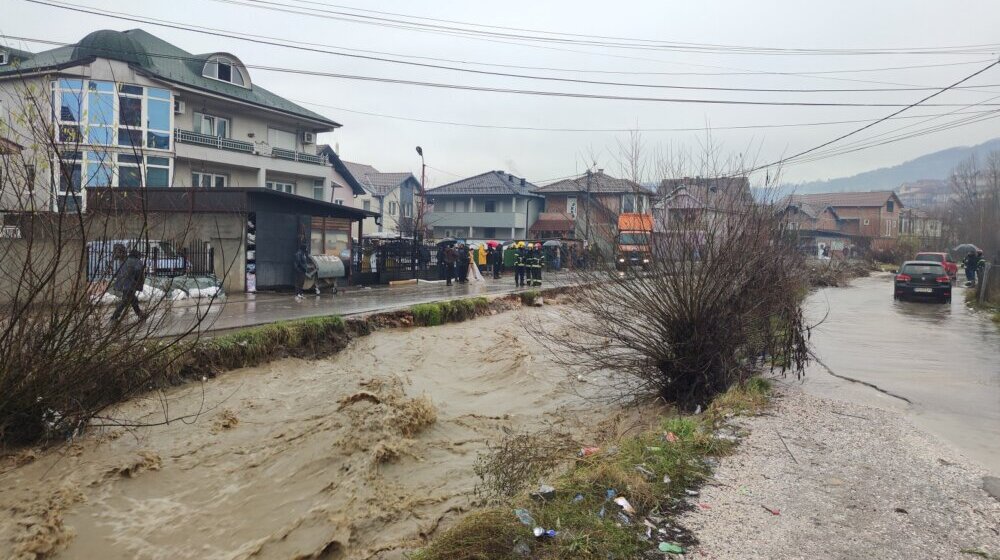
[86,240,215,282]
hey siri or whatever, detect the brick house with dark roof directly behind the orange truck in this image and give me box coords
[531,169,654,255]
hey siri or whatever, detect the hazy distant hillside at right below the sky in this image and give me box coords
[784,138,1000,194]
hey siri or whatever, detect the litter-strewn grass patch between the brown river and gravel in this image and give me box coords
[412,379,770,560]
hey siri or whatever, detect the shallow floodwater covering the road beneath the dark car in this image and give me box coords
[804,275,1000,475]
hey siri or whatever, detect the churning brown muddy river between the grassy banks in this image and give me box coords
[0,309,610,560]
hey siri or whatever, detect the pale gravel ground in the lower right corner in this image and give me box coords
[682,388,1000,560]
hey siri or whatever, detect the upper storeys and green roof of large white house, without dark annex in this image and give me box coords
[0,29,360,209]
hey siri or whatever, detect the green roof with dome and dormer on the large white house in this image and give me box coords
[0,29,340,128]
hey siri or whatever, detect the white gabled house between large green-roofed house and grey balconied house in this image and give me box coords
[343,161,423,237]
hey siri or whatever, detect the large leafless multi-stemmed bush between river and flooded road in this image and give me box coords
[530,135,808,404]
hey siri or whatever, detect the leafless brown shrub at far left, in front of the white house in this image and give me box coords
[0,74,228,447]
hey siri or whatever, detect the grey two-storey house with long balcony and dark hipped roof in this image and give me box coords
[426,171,544,240]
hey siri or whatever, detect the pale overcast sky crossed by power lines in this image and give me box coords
[0,0,1000,187]
